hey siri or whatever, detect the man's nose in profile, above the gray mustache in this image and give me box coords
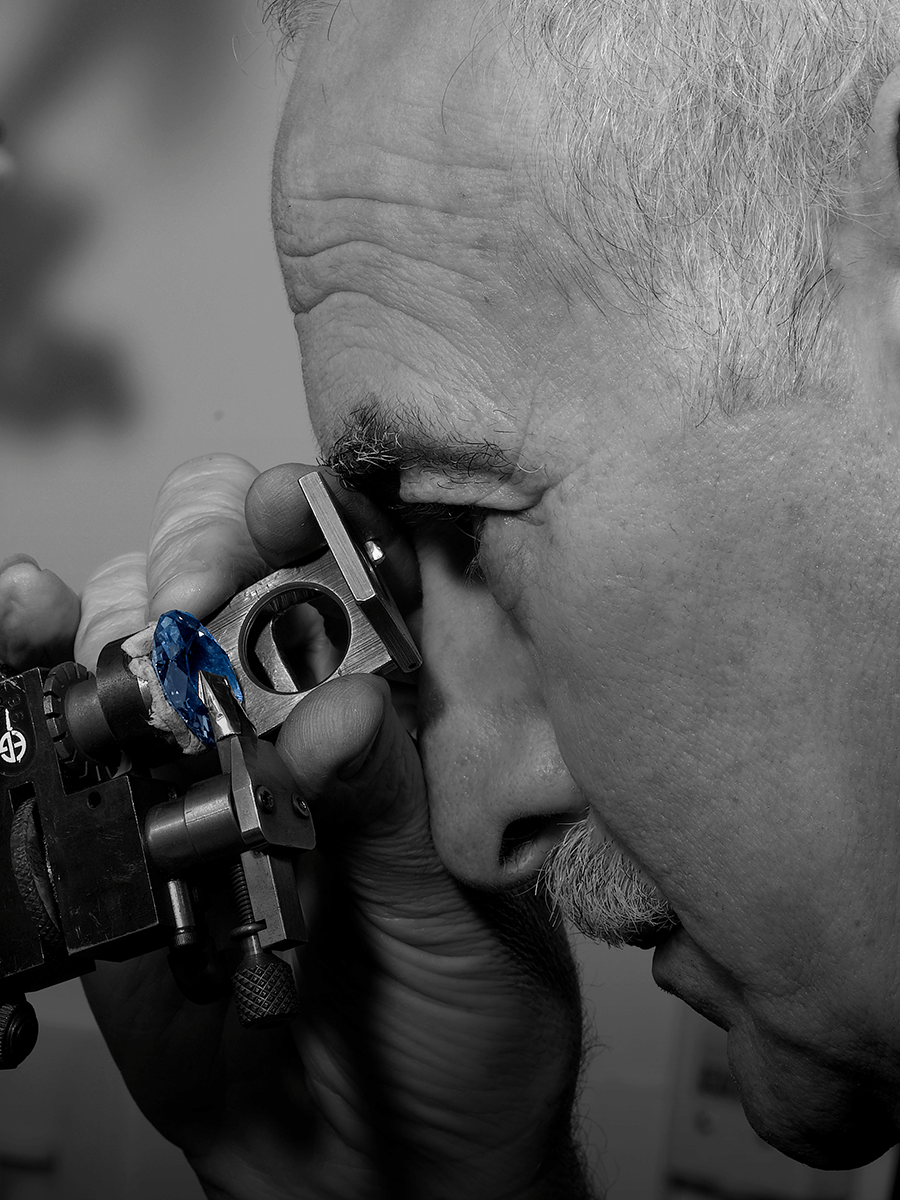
[419,540,586,888]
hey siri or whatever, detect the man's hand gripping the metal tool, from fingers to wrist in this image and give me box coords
[0,456,587,1200]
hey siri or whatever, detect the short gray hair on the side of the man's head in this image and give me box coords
[509,0,900,416]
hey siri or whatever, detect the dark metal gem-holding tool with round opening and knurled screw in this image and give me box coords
[0,473,420,1067]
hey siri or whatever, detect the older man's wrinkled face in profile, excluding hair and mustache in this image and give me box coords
[275,0,900,1162]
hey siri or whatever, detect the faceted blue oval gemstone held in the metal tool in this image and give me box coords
[150,608,244,745]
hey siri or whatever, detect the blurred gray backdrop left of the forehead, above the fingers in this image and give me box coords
[0,0,311,587]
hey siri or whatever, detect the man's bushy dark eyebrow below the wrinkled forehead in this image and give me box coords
[324,397,522,497]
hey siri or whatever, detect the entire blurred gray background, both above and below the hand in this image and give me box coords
[0,0,892,1200]
